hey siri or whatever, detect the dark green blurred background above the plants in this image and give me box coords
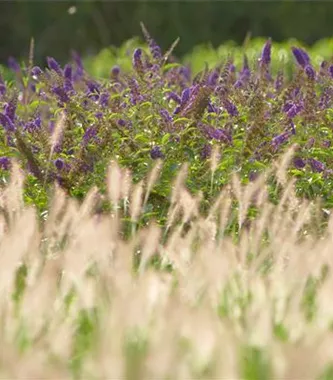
[0,0,333,63]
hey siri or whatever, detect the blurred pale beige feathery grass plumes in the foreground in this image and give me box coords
[0,149,333,379]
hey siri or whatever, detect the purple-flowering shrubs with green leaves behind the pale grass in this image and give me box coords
[0,25,333,222]
